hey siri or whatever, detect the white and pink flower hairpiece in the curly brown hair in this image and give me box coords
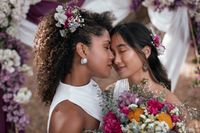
[54,5,84,37]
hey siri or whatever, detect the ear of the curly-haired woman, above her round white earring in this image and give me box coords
[76,42,88,58]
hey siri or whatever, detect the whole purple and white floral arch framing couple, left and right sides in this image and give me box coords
[0,0,200,132]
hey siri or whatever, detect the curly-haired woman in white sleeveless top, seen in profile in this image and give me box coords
[34,6,113,133]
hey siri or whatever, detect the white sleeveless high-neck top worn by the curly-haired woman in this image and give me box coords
[47,80,102,133]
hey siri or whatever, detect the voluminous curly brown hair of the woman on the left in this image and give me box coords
[34,7,114,104]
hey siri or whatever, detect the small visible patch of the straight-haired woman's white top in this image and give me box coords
[113,79,129,100]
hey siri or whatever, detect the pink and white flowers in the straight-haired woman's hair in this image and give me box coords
[150,34,166,55]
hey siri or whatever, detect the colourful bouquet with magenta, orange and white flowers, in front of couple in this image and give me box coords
[102,81,186,133]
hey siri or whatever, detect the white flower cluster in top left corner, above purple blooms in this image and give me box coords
[0,0,41,36]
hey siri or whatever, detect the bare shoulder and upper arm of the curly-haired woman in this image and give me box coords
[49,100,84,133]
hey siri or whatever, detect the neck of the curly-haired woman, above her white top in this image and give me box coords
[63,61,91,86]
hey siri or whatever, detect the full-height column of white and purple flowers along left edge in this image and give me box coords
[0,0,40,132]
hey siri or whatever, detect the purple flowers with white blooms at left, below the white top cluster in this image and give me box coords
[0,32,32,131]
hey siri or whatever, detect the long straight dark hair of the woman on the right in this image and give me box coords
[111,22,171,90]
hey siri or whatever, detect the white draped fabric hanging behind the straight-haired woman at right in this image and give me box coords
[148,7,190,92]
